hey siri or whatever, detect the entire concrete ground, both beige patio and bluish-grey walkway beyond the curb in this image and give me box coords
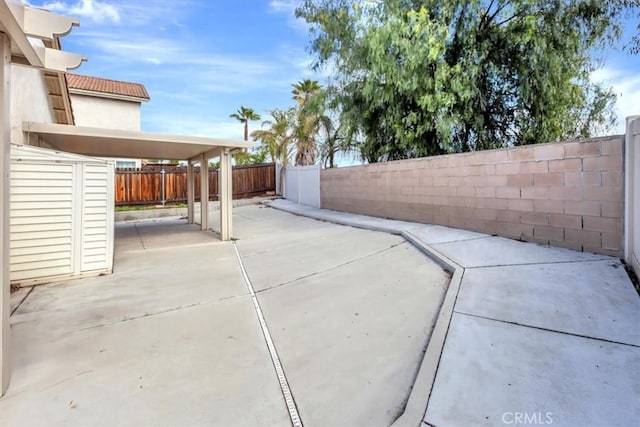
[0,200,640,426]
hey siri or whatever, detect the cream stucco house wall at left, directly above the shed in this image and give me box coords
[10,65,55,144]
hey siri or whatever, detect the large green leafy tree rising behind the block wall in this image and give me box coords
[296,0,637,162]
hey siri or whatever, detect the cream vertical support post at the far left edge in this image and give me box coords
[0,33,11,396]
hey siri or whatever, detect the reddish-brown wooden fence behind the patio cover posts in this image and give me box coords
[115,163,276,206]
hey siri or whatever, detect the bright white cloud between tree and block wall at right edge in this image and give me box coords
[591,67,640,134]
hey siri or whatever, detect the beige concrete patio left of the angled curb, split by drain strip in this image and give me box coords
[0,205,450,426]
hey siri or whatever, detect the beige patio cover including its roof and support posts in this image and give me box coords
[22,122,253,240]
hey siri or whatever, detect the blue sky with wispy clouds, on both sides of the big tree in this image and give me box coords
[29,0,640,139]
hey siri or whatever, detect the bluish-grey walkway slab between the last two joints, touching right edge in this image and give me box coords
[455,260,640,346]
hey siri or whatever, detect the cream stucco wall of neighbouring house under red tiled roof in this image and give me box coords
[71,94,140,131]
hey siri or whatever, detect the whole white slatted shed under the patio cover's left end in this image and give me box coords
[9,144,114,284]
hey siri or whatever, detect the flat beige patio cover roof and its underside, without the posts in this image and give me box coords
[22,122,253,160]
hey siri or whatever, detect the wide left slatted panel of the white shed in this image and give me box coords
[10,162,73,281]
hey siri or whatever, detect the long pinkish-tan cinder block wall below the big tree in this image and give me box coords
[320,136,624,257]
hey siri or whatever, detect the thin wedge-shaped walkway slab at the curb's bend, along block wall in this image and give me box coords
[432,237,613,268]
